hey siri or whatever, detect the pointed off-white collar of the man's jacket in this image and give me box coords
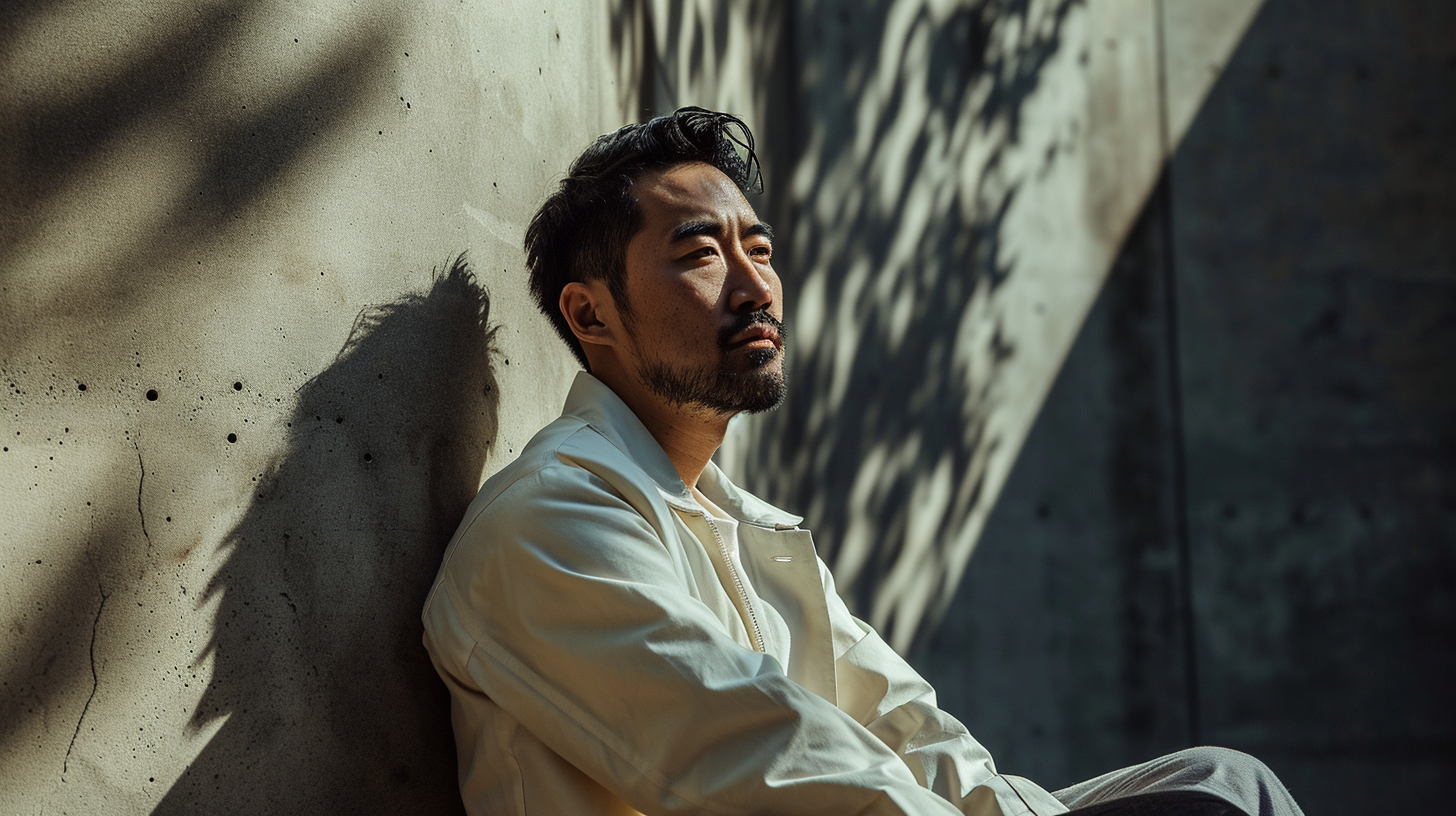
[562,372,804,529]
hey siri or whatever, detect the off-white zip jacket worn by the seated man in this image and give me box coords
[424,373,1066,816]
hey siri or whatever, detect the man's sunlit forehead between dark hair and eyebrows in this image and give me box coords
[632,162,759,233]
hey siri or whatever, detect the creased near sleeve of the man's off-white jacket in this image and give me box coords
[430,466,958,816]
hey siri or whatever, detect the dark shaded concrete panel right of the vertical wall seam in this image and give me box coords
[1171,0,1456,813]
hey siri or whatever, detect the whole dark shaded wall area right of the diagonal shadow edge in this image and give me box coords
[914,0,1456,815]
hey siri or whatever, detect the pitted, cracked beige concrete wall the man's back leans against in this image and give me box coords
[0,0,635,815]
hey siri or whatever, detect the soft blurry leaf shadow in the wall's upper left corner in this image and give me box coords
[0,0,408,350]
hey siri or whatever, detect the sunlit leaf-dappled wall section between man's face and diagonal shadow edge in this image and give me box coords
[737,0,1258,648]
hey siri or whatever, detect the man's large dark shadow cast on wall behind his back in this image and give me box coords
[154,256,498,816]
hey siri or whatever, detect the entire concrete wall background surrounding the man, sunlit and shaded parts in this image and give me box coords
[8,0,1456,813]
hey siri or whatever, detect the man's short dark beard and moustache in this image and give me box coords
[638,312,789,414]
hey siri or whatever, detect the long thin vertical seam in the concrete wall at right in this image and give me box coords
[1153,0,1203,745]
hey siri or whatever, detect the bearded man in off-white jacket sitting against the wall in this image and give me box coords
[424,108,1299,816]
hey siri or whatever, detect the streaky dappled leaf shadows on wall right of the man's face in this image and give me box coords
[744,0,1082,650]
